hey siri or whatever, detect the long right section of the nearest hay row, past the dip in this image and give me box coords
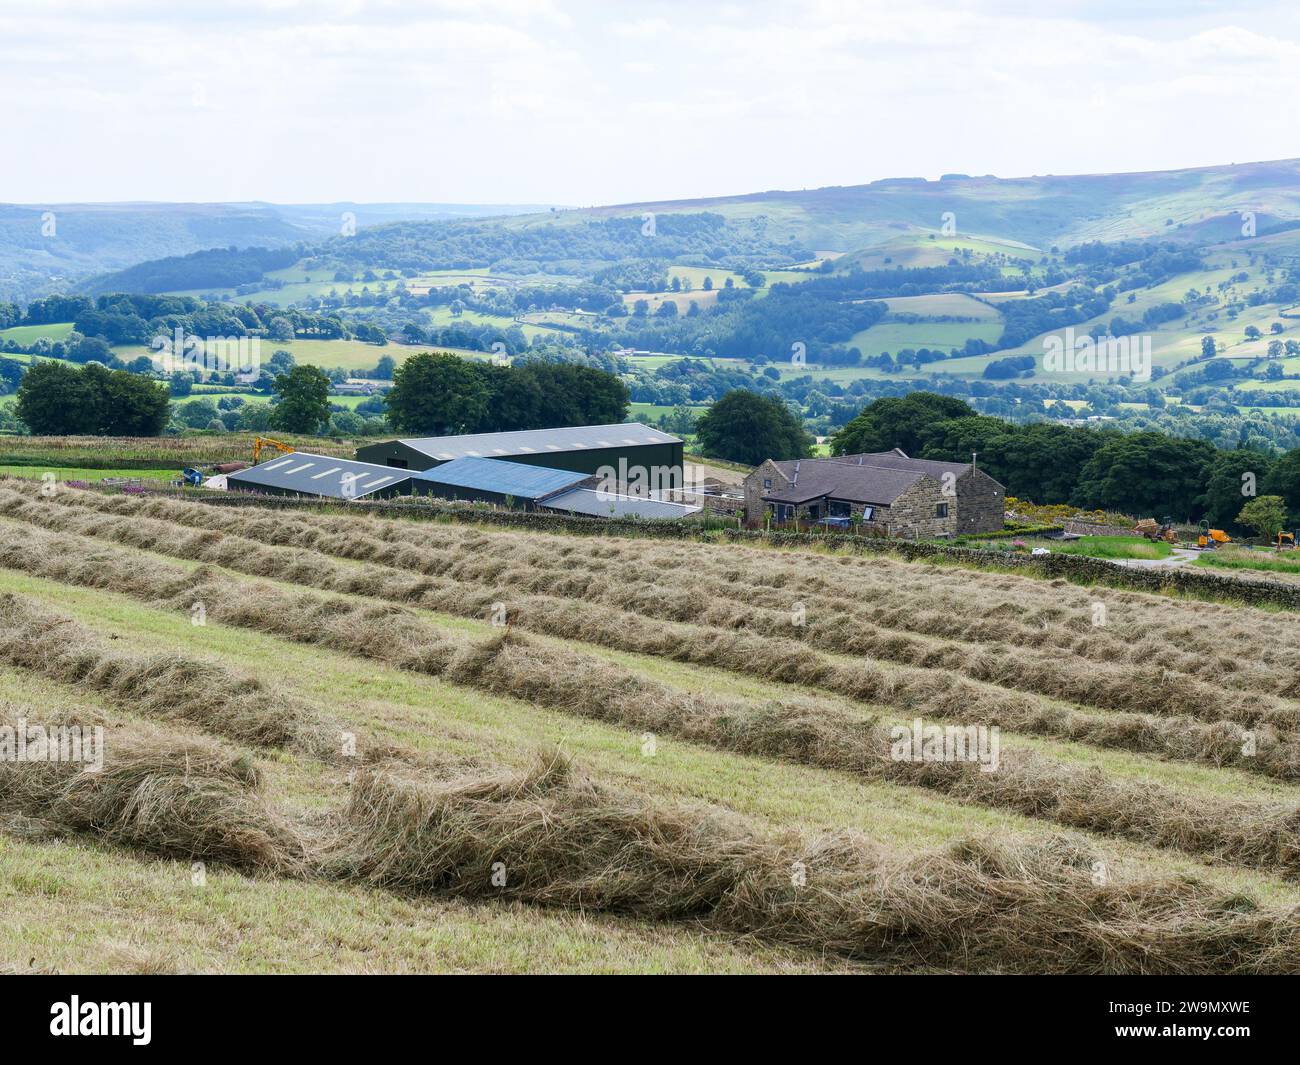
[328,756,1300,974]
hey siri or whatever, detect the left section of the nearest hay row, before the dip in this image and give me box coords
[0,705,306,873]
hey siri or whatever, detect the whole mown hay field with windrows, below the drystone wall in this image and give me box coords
[0,477,1300,973]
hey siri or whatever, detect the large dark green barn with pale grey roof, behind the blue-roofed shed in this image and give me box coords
[356,421,684,490]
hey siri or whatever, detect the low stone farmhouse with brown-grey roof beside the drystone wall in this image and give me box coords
[745,449,1006,538]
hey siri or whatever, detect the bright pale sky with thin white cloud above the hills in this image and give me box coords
[0,0,1300,207]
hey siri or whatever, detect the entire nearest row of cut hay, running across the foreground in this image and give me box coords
[0,707,1300,974]
